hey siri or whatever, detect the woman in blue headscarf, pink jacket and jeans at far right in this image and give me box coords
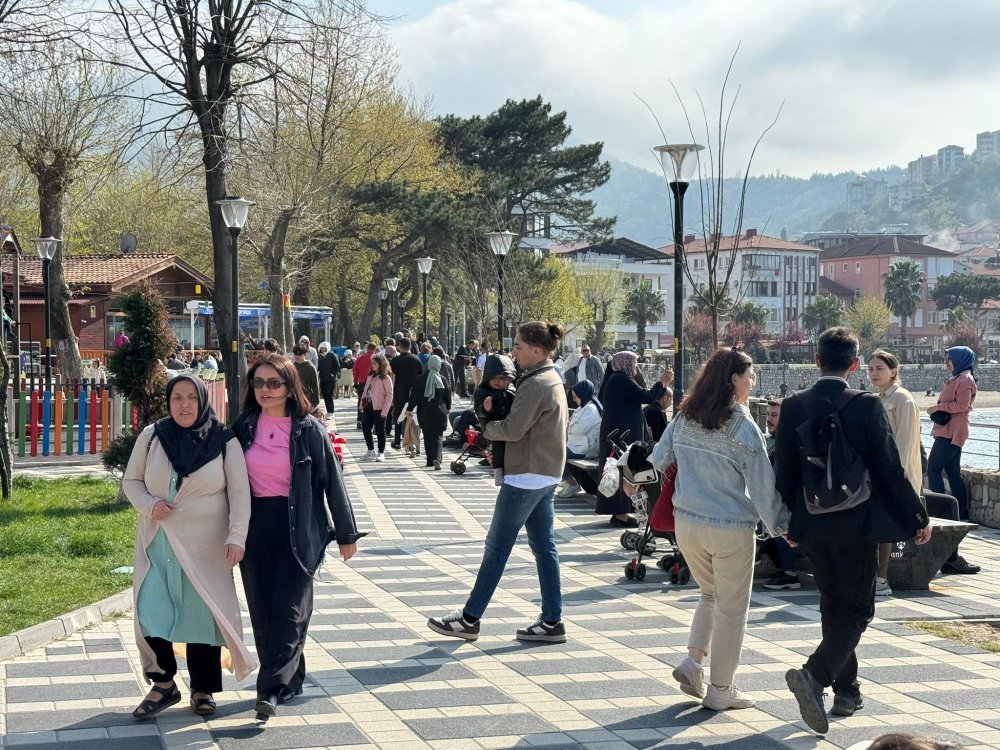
[927,346,976,521]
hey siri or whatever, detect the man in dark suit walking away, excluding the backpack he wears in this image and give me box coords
[774,328,931,734]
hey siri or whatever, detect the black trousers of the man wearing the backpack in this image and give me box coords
[802,541,878,694]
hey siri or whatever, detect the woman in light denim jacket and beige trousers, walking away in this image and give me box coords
[650,347,788,711]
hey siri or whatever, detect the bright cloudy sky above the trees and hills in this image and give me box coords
[369,0,1000,177]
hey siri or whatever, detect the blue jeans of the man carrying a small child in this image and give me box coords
[465,484,562,623]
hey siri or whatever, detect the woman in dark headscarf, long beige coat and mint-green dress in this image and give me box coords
[122,375,257,719]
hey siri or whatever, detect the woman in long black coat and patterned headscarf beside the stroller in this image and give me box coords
[594,351,674,528]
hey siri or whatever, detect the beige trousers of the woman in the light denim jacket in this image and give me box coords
[677,518,754,688]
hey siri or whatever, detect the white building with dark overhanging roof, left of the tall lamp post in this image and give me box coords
[549,237,674,350]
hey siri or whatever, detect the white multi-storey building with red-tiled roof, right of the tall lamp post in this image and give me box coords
[680,229,819,334]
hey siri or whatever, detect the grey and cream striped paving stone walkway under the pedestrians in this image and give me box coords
[0,400,1000,750]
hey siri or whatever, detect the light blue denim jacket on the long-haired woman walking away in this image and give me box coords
[649,404,788,536]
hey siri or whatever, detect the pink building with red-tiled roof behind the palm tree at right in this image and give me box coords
[820,234,965,359]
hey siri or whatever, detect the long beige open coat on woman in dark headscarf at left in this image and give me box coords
[122,425,257,680]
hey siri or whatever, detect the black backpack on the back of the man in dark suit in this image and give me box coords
[796,389,871,514]
